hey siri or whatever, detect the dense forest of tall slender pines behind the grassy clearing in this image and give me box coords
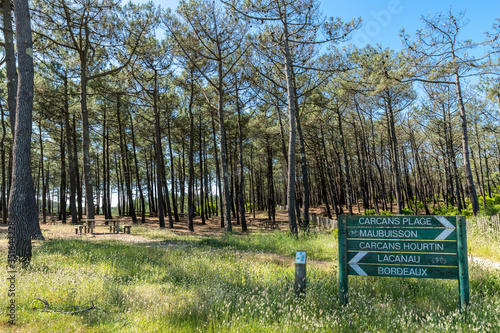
[0,0,500,246]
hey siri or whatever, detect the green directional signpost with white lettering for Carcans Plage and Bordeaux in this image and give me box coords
[338,215,469,309]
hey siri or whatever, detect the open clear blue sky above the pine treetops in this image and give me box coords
[134,0,500,50]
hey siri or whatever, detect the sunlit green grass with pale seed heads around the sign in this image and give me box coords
[0,224,500,332]
